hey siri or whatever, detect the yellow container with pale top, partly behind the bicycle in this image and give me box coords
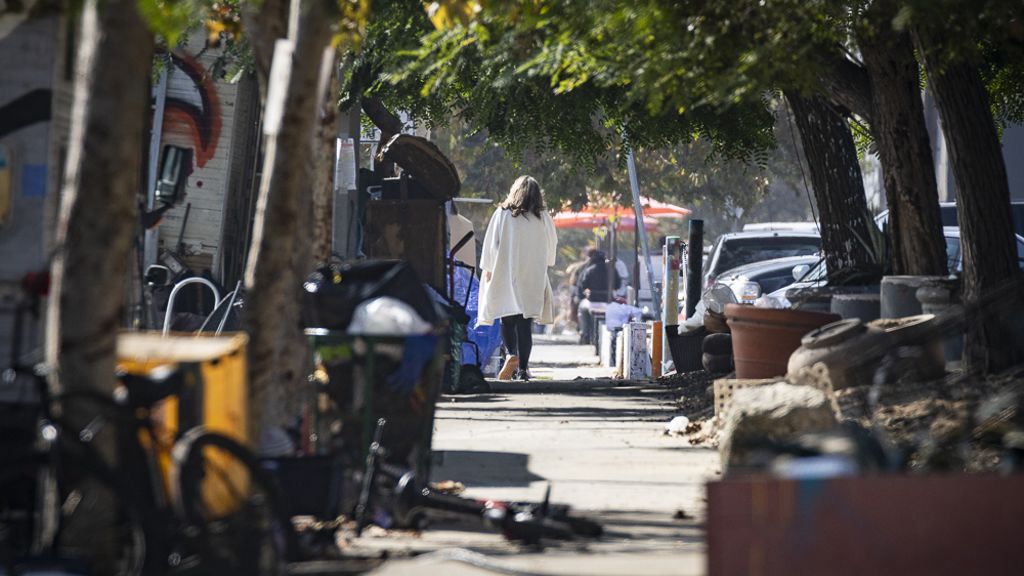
[118,332,251,513]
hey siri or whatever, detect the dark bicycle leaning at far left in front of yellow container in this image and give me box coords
[0,272,296,576]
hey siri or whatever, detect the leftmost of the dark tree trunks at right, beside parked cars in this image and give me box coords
[785,92,877,282]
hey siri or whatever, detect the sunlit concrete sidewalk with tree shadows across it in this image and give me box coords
[355,337,718,576]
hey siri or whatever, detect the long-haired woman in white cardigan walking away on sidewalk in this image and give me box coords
[478,176,558,380]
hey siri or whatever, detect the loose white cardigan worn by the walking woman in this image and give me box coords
[477,208,558,326]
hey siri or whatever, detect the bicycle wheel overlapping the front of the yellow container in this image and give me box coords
[171,427,294,576]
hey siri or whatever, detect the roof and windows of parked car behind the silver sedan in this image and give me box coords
[702,231,821,289]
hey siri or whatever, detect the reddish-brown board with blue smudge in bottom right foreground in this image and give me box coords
[708,475,1024,576]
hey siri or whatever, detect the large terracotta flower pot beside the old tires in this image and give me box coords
[725,304,840,378]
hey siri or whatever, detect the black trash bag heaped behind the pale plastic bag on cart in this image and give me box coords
[302,260,441,330]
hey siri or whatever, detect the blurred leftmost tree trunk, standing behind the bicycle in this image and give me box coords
[46,0,153,422]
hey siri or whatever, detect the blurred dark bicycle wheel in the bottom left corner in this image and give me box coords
[0,448,148,576]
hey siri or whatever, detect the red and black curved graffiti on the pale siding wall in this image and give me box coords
[164,55,221,168]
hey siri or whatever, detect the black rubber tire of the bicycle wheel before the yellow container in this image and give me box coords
[170,426,298,576]
